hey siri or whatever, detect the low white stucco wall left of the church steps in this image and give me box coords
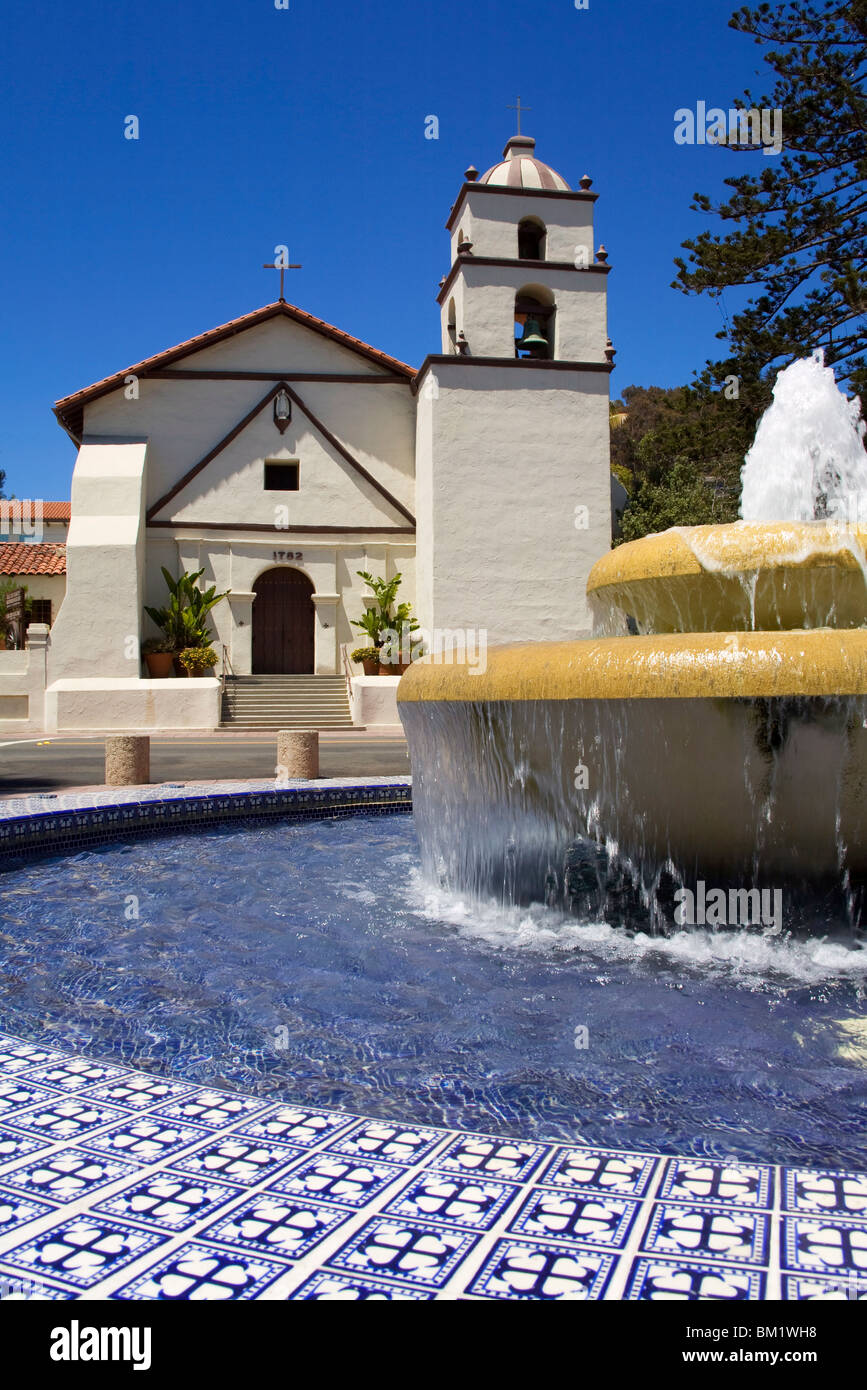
[46,677,220,733]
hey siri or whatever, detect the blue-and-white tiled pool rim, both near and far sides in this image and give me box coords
[0,777,867,1302]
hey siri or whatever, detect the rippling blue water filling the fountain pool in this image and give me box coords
[0,815,867,1168]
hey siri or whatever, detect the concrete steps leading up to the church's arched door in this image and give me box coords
[221,676,353,728]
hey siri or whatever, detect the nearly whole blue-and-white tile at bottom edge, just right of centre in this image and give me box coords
[467,1238,616,1302]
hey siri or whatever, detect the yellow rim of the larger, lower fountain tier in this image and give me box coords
[397,628,867,705]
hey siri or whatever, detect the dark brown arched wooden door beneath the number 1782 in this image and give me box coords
[253,567,315,676]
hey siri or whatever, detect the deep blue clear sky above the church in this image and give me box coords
[0,0,770,498]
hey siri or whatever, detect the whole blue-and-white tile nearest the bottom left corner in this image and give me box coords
[3,1213,163,1290]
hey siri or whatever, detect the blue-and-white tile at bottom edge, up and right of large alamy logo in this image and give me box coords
[111,1241,286,1302]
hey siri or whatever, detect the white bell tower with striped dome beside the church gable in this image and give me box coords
[415,135,614,645]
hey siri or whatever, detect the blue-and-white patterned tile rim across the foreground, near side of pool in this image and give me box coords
[0,1027,867,1301]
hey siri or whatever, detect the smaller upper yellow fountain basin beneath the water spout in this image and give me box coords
[588,521,867,632]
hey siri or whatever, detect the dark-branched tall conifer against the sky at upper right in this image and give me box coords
[674,0,867,393]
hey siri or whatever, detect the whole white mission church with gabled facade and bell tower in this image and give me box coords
[0,135,613,731]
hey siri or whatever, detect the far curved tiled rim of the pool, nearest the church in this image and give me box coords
[0,777,413,870]
